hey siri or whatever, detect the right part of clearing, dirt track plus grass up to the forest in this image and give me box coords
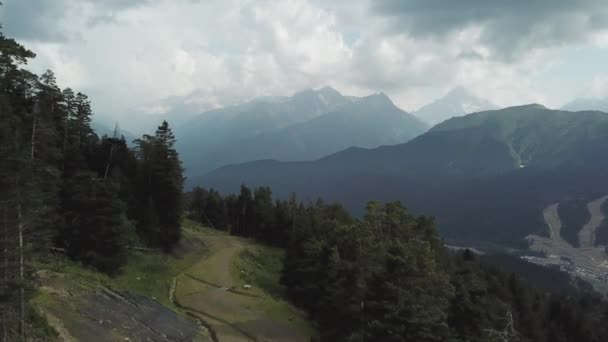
[175,223,314,341]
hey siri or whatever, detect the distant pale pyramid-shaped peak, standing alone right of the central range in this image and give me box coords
[413,87,498,125]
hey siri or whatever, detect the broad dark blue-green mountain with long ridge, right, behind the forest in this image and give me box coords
[195,105,608,245]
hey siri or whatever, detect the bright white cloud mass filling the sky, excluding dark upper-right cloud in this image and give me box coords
[0,0,608,127]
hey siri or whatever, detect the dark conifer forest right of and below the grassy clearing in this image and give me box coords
[186,185,608,342]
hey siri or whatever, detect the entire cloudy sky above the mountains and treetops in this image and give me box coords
[0,0,608,130]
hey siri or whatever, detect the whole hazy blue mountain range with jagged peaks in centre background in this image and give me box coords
[176,87,428,177]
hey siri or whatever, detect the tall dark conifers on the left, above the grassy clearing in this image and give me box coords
[0,26,183,341]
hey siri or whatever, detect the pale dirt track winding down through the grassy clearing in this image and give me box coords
[175,233,310,342]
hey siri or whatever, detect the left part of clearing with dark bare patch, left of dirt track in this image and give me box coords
[33,228,211,342]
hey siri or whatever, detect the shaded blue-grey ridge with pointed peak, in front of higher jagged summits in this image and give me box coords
[200,94,428,169]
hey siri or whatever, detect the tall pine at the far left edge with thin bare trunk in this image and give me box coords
[0,24,40,340]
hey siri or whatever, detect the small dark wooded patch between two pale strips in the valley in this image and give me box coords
[557,199,591,247]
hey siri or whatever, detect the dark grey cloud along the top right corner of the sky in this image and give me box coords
[372,0,608,59]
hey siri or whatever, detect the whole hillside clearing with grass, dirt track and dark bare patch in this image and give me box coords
[33,221,313,342]
